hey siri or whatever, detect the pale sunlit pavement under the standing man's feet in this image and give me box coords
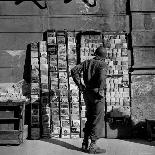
[0,138,155,155]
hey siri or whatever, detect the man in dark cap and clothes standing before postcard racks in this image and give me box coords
[71,46,107,154]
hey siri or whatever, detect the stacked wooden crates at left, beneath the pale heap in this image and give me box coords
[0,102,28,144]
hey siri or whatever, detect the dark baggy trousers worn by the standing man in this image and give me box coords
[83,90,105,141]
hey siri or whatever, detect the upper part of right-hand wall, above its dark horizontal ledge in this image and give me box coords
[130,0,155,68]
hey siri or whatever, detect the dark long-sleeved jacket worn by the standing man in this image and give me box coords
[71,57,107,95]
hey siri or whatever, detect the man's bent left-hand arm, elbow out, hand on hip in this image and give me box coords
[71,63,85,91]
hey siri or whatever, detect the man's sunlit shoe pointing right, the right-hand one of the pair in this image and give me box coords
[88,143,106,154]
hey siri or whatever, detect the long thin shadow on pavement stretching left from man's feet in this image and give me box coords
[41,139,82,152]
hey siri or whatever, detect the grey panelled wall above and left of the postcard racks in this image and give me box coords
[0,0,129,83]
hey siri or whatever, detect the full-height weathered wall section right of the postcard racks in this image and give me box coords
[130,0,155,137]
